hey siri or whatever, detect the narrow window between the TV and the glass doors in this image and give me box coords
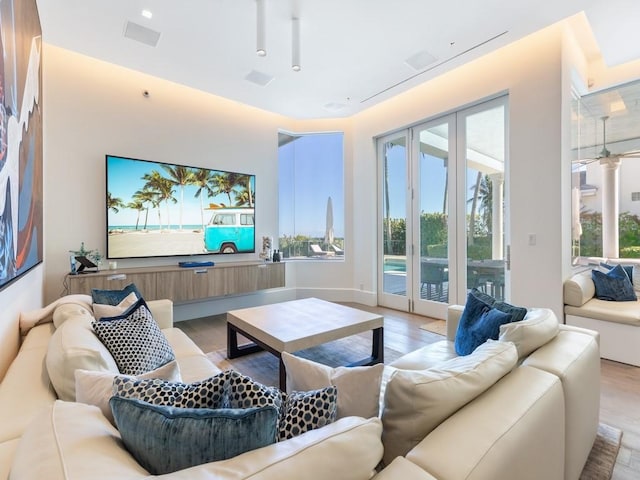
[276,132,344,261]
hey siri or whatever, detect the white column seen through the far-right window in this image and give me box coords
[600,158,620,258]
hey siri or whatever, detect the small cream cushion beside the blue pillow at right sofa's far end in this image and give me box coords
[499,308,560,358]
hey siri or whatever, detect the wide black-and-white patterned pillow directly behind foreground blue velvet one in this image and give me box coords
[113,372,229,408]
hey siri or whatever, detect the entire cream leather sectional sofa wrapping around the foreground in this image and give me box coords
[0,296,600,480]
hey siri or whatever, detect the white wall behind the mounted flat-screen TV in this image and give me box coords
[43,44,304,319]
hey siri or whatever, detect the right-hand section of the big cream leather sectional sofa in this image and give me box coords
[376,306,600,480]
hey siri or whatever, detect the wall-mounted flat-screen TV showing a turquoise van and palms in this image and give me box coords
[106,155,256,258]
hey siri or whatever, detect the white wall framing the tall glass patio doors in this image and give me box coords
[353,25,570,315]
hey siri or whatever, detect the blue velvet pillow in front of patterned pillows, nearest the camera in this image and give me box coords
[109,397,278,475]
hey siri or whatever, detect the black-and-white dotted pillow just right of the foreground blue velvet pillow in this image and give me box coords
[279,386,338,441]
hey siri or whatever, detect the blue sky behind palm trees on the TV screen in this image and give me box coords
[107,156,255,226]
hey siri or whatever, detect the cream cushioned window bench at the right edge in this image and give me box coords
[563,268,640,366]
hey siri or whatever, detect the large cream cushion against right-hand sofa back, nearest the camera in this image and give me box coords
[382,340,518,464]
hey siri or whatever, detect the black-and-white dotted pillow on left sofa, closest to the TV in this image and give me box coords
[91,299,176,375]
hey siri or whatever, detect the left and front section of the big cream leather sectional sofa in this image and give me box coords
[0,295,382,480]
